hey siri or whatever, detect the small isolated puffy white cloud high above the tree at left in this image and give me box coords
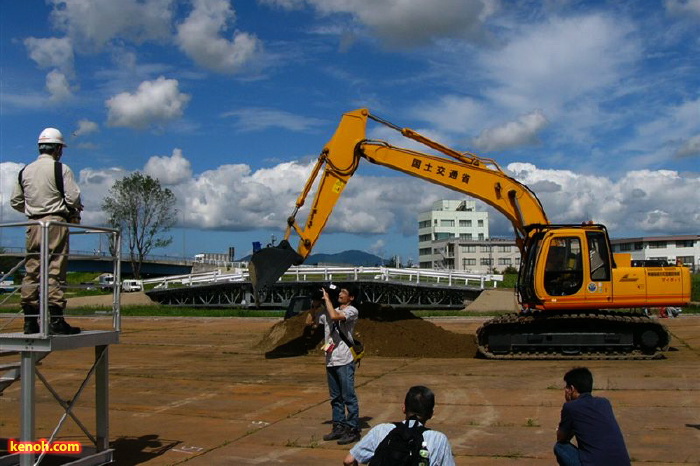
[105,76,190,129]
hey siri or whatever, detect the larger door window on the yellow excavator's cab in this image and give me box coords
[544,237,583,296]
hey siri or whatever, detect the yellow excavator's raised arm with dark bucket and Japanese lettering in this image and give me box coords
[249,109,549,289]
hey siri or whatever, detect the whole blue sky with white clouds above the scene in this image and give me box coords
[0,0,700,261]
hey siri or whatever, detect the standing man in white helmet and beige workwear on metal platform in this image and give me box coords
[10,128,83,335]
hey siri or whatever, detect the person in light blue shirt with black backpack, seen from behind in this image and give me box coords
[343,385,455,466]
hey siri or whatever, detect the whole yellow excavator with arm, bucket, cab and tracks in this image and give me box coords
[249,109,691,359]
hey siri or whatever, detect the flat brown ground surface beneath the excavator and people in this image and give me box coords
[0,316,700,466]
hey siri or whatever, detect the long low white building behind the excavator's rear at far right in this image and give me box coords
[610,235,700,272]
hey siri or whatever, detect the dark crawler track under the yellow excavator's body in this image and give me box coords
[476,310,671,359]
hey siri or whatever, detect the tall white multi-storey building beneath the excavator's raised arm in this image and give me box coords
[418,200,489,268]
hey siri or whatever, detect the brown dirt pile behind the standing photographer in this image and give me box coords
[256,304,477,358]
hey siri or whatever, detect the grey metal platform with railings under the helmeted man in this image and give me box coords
[0,221,121,466]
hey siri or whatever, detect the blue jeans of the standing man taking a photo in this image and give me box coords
[326,362,360,429]
